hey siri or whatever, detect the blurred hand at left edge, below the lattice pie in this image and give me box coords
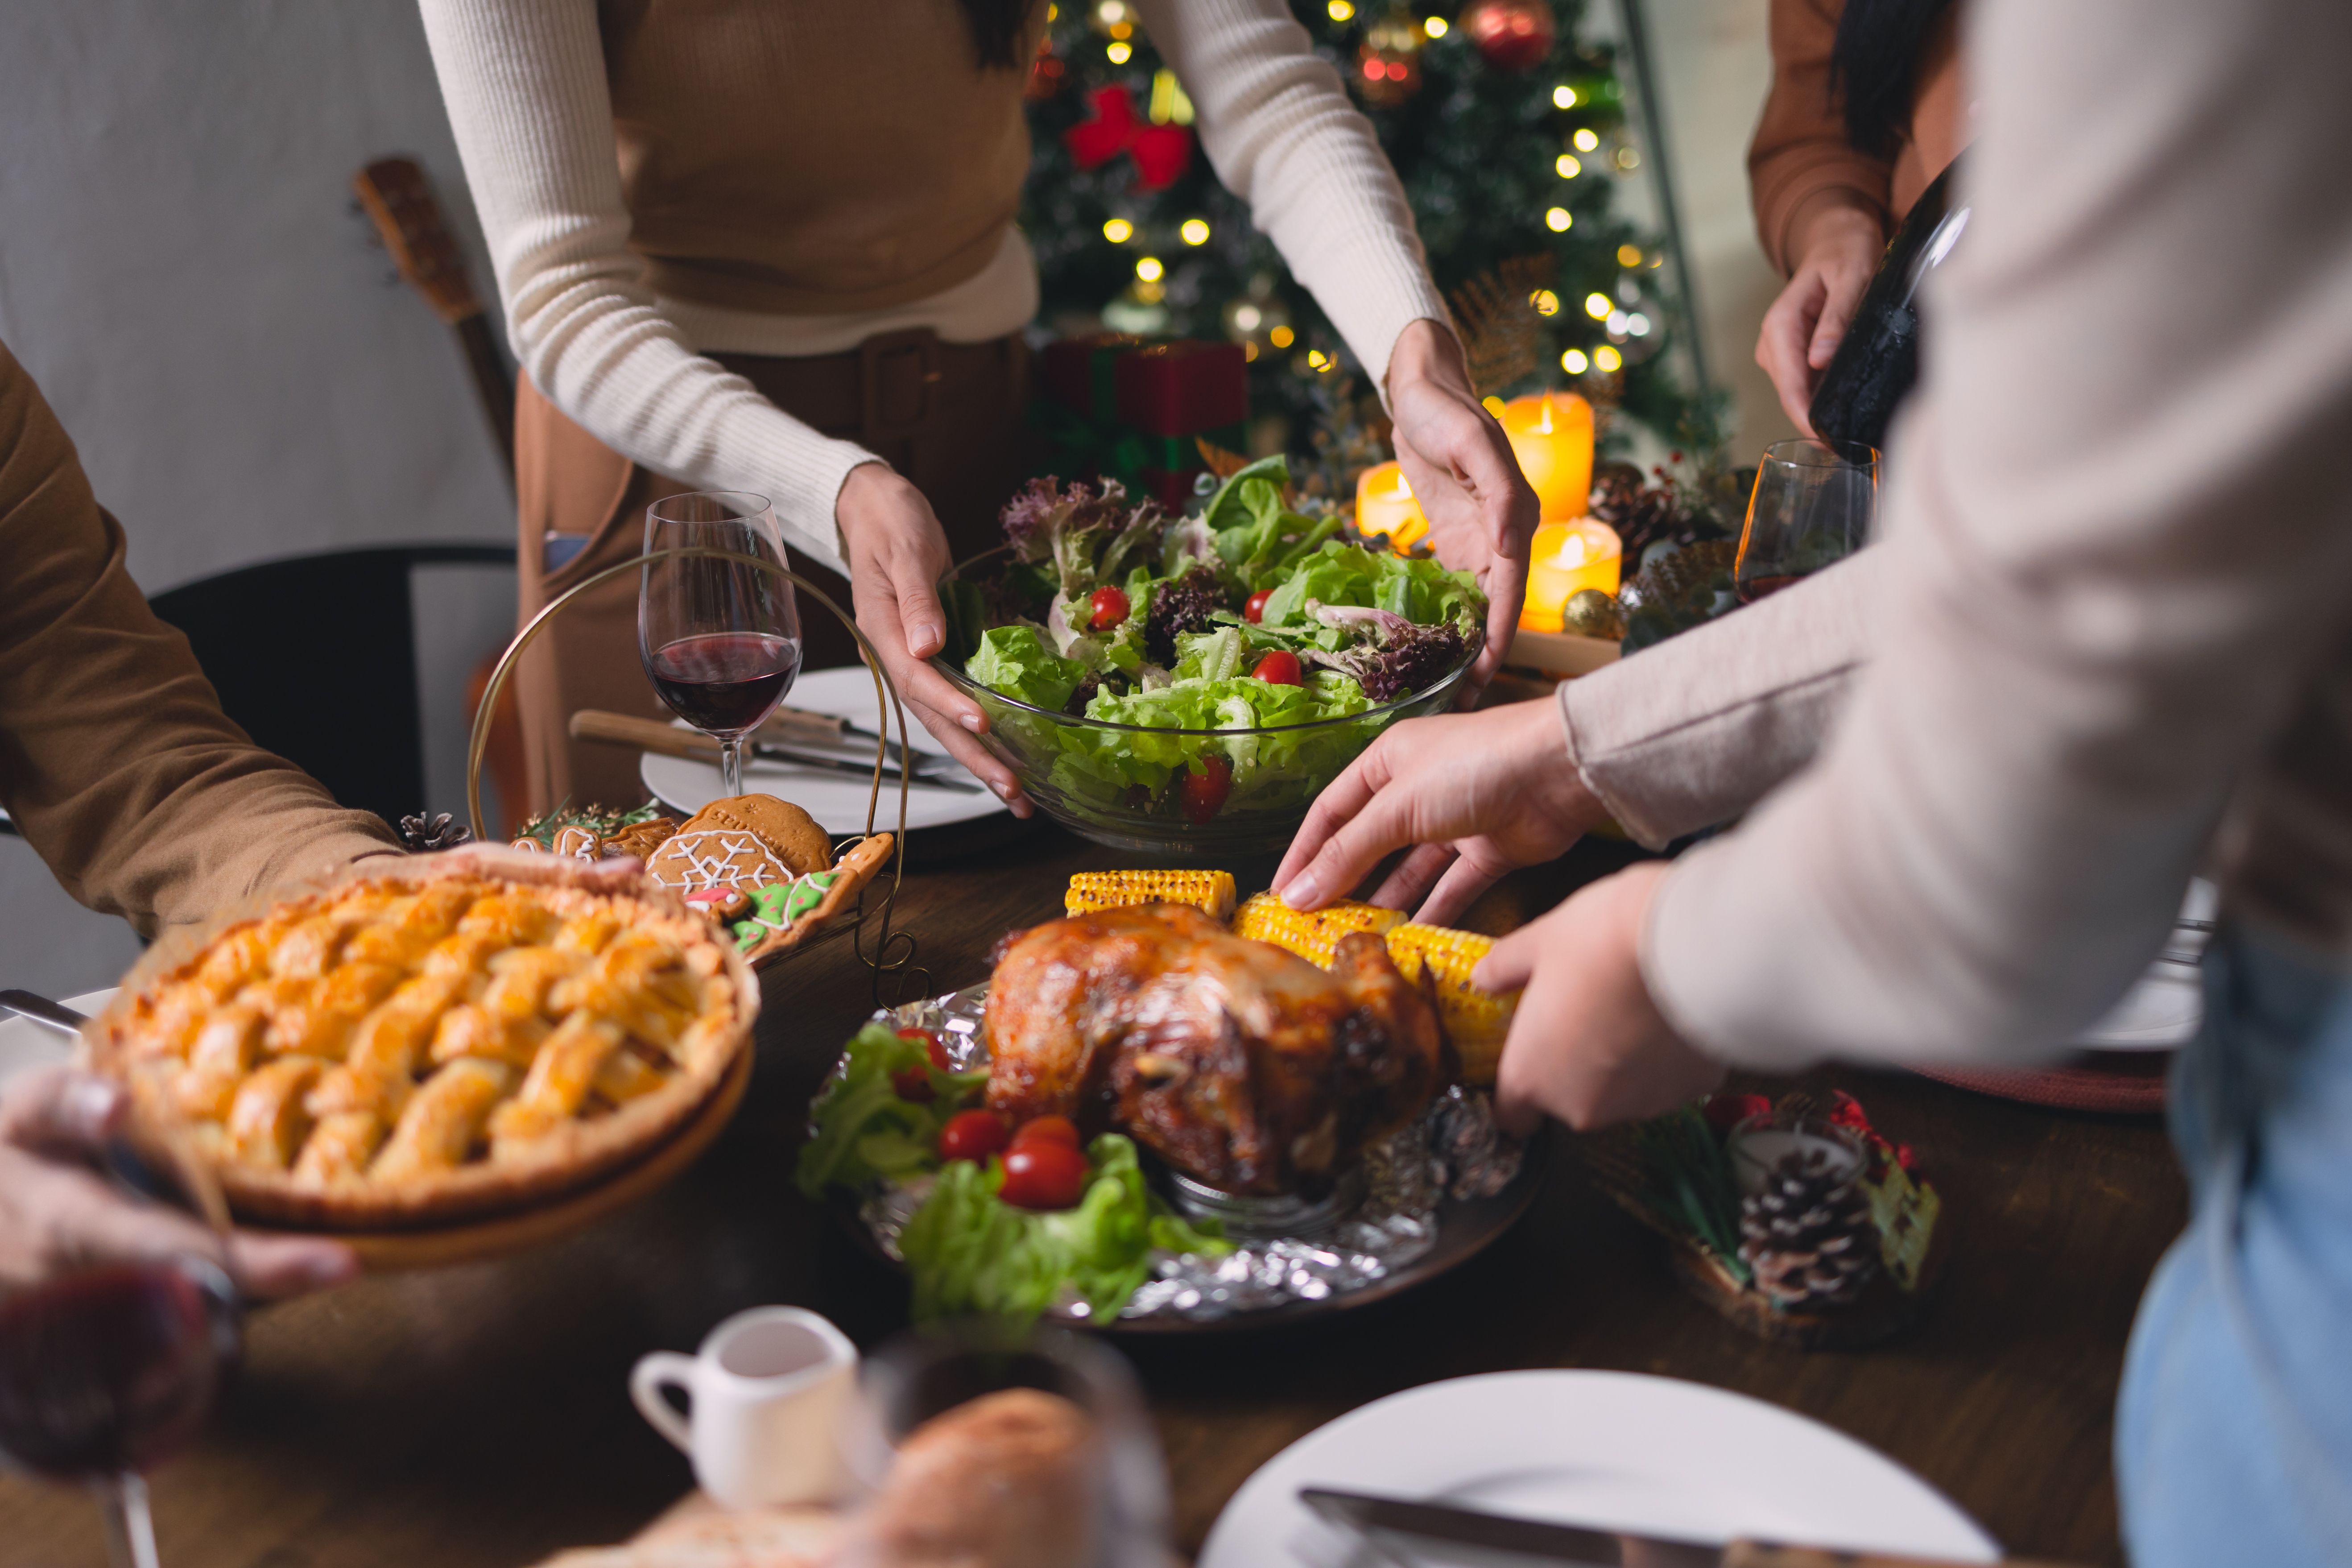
[0,1067,360,1298]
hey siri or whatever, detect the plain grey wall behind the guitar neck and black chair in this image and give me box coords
[0,0,513,994]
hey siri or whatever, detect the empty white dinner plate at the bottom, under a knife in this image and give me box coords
[1199,1370,1999,1568]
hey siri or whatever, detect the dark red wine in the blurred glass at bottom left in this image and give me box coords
[0,1258,240,1481]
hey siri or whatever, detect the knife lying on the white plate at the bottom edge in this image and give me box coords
[1298,1486,2088,1568]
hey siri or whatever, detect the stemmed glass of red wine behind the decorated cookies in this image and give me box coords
[637,491,800,794]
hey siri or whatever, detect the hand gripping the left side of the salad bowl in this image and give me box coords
[833,463,1033,816]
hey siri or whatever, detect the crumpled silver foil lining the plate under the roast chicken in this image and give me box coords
[837,983,1545,1335]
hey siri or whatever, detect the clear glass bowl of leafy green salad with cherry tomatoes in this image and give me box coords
[936,447,1489,858]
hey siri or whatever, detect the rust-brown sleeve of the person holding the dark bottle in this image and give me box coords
[1748,0,1891,277]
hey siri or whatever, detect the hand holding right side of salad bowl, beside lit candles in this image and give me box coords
[1388,320,1536,687]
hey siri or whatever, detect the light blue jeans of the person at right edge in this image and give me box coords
[2114,929,2352,1568]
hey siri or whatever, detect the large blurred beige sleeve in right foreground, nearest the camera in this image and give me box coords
[1644,0,2352,1067]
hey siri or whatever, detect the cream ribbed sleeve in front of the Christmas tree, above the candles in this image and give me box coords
[1138,0,1454,397]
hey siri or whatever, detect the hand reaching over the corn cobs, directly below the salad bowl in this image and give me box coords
[1275,703,1606,924]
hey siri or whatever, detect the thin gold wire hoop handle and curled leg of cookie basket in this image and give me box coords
[466,546,931,1006]
